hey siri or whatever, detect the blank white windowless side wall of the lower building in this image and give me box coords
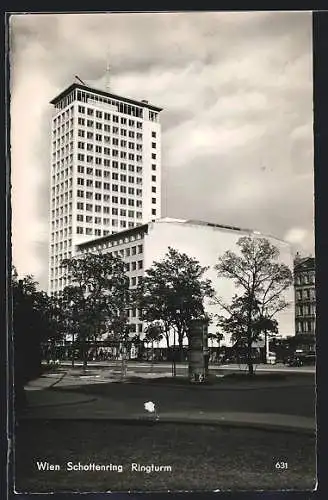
[144,220,295,346]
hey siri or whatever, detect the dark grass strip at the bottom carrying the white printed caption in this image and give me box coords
[16,421,315,493]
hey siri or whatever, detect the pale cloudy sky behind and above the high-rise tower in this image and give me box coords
[10,12,314,288]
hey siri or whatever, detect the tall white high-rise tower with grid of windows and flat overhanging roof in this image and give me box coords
[48,83,162,293]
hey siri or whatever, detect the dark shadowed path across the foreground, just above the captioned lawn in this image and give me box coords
[21,389,315,435]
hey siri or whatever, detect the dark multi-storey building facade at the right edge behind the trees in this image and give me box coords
[294,255,316,336]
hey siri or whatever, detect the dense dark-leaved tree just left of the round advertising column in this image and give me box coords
[136,247,214,359]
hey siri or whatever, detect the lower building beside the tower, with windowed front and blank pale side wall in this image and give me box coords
[77,218,295,346]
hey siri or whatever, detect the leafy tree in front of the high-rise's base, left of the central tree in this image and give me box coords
[62,253,131,368]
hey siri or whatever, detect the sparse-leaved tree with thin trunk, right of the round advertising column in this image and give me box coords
[215,236,293,375]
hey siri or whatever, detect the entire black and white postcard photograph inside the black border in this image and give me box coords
[8,11,317,494]
